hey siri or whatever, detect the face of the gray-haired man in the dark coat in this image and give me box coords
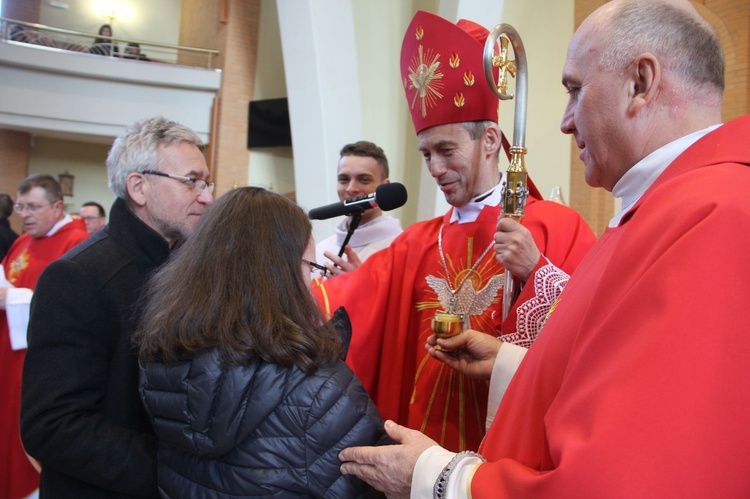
[140,142,214,244]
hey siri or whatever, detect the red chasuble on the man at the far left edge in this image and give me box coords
[0,223,88,499]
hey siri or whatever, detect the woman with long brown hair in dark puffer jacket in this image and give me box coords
[136,187,384,497]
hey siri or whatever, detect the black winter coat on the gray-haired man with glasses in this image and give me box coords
[21,199,169,499]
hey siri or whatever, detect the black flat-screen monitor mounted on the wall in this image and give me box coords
[247,98,292,149]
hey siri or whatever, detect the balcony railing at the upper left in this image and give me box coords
[0,17,219,69]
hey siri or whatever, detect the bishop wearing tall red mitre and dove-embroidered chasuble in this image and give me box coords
[314,8,595,451]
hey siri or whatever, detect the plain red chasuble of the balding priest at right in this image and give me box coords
[471,117,750,499]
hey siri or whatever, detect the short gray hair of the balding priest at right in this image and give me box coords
[600,1,725,92]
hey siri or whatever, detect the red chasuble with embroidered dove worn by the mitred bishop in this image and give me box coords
[314,197,595,451]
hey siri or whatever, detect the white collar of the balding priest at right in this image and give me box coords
[609,123,721,227]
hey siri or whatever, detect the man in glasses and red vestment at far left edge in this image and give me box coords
[0,174,88,497]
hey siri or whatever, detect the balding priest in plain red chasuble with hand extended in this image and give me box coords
[340,0,750,499]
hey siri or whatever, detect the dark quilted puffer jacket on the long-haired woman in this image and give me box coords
[140,351,384,498]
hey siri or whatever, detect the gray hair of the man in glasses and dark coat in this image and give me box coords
[107,116,203,201]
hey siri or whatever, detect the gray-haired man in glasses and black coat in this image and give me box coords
[21,117,214,498]
